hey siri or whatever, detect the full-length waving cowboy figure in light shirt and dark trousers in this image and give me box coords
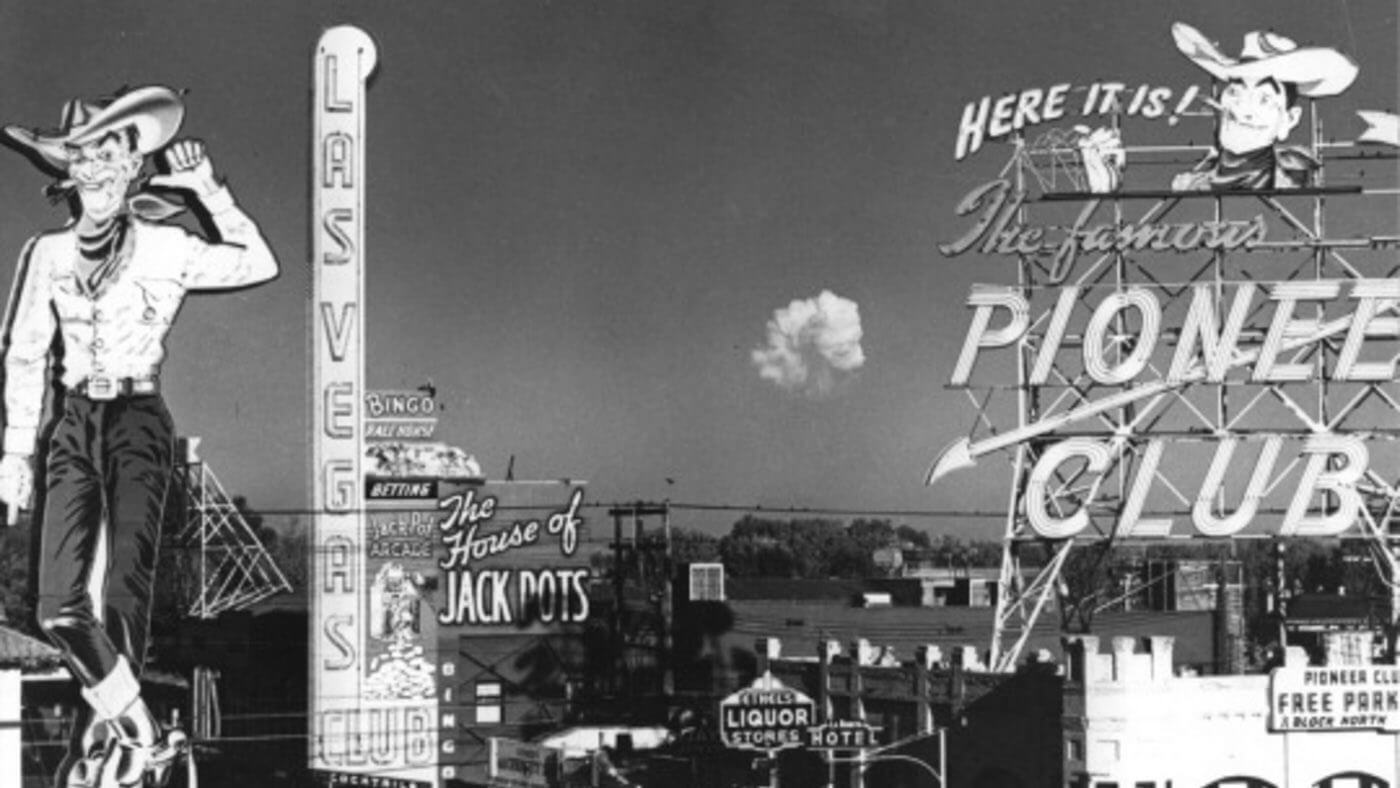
[0,87,277,788]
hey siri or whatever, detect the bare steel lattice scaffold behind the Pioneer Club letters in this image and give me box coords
[966,116,1400,672]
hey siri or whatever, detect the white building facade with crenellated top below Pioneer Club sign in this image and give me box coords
[1064,635,1400,788]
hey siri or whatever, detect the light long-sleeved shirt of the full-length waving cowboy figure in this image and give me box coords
[4,188,277,455]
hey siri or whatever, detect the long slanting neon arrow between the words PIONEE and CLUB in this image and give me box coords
[924,309,1372,486]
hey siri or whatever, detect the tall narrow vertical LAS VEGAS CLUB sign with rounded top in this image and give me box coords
[308,27,375,773]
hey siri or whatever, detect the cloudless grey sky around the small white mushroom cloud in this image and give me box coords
[0,0,1397,536]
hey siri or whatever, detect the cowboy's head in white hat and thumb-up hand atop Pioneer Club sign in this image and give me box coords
[1079,22,1358,192]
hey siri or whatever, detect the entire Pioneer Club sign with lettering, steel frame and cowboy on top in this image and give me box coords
[925,22,1400,669]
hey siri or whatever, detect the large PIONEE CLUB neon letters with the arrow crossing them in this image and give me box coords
[931,280,1400,539]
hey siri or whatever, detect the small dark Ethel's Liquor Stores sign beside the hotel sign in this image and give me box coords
[720,675,816,752]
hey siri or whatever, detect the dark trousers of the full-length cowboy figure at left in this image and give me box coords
[38,392,175,687]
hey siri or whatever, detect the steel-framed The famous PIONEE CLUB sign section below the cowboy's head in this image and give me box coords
[928,106,1400,670]
